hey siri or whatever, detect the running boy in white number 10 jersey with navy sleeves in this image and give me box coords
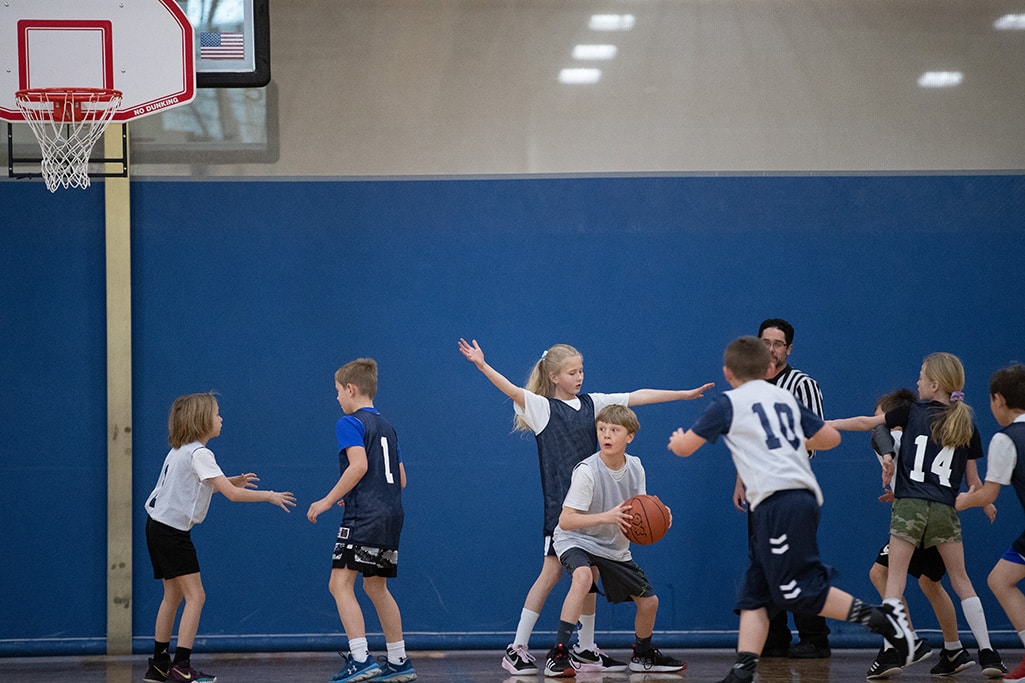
[669,336,914,683]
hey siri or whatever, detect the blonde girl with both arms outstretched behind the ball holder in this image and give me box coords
[459,339,713,676]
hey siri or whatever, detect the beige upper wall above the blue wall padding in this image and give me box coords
[126,0,1025,176]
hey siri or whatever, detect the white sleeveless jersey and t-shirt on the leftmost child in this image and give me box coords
[146,441,224,531]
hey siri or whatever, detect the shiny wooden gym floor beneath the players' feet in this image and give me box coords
[0,649,1022,683]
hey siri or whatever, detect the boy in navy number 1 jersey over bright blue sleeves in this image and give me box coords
[306,358,416,683]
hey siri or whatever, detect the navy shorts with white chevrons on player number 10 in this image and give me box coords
[737,489,831,614]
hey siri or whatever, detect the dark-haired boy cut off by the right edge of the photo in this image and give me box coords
[955,363,1025,682]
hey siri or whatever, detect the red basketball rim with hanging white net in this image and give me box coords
[14,88,121,192]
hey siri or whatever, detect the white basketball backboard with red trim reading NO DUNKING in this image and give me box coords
[0,0,196,122]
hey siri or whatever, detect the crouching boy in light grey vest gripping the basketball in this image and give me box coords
[544,404,687,678]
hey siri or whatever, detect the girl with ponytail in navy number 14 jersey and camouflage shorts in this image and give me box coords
[829,353,1007,676]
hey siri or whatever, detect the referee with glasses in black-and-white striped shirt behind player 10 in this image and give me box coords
[759,318,831,659]
